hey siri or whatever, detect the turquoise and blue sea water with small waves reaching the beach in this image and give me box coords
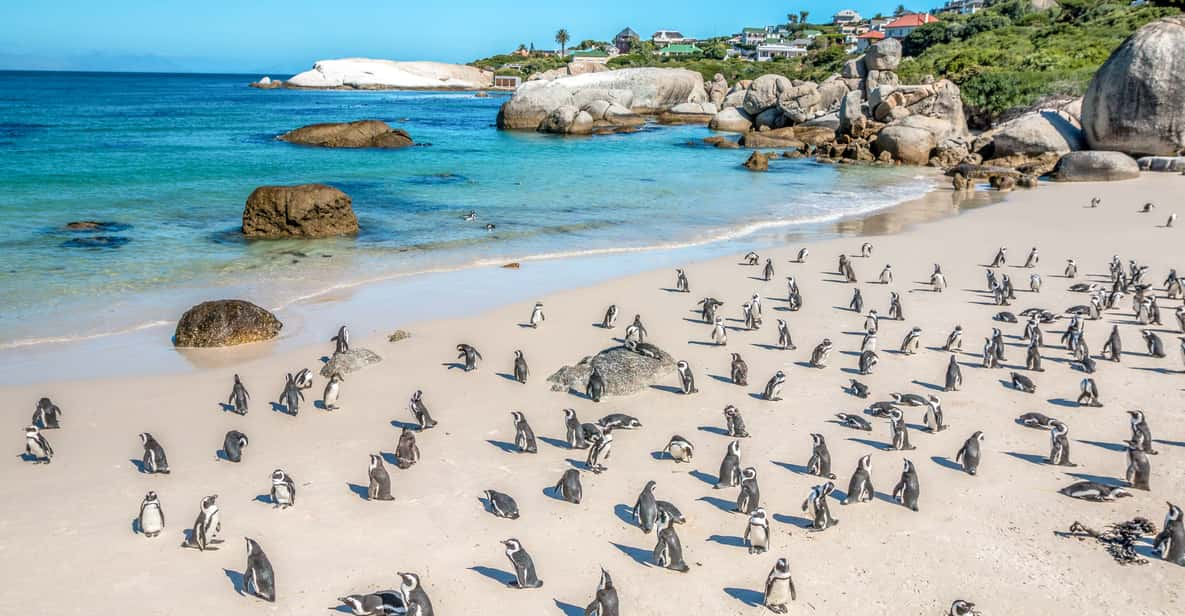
[0,72,930,347]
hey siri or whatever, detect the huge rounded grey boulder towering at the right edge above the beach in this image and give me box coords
[1082,15,1185,155]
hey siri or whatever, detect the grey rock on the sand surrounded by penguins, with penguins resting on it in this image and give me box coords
[547,342,675,396]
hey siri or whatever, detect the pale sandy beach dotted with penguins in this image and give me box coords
[0,174,1185,616]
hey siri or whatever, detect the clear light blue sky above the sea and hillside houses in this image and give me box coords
[0,0,914,77]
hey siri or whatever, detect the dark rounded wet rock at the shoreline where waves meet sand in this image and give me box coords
[173,300,283,347]
